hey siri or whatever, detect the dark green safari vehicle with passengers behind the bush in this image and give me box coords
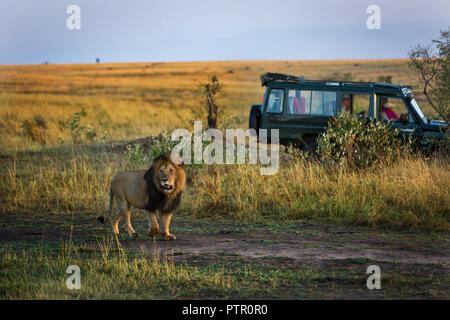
[249,73,446,150]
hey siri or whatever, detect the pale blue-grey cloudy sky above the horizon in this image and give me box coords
[0,0,450,64]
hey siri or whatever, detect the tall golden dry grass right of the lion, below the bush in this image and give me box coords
[185,159,450,230]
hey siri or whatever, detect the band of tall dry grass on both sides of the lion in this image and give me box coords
[0,150,450,230]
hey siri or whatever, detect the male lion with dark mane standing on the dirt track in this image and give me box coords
[98,152,186,240]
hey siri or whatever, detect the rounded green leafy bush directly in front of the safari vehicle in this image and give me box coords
[318,114,411,168]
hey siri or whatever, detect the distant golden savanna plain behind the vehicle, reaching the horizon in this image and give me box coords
[0,60,431,151]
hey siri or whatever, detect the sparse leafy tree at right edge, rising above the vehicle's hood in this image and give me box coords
[408,27,450,123]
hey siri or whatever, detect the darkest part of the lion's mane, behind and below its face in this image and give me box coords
[144,154,183,214]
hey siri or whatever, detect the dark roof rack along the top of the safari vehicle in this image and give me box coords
[261,72,417,89]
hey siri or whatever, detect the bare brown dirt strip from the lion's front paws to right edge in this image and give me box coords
[125,233,450,270]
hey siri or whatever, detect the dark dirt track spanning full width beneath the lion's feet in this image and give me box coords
[0,216,450,270]
